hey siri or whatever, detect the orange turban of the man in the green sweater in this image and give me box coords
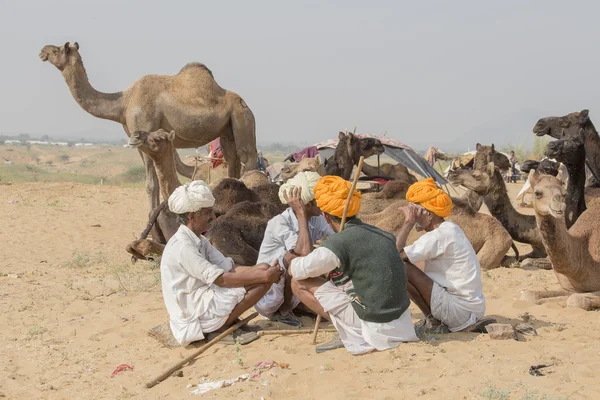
[315,175,362,218]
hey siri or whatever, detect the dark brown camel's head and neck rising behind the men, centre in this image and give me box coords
[325,132,385,180]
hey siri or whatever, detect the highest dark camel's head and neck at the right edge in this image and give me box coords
[533,110,600,187]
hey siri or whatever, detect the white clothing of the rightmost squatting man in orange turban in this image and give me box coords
[404,221,485,332]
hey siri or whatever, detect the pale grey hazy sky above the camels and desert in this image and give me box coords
[0,0,600,149]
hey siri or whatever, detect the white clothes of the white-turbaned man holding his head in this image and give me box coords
[254,208,334,318]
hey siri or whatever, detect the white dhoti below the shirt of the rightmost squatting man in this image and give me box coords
[430,282,484,332]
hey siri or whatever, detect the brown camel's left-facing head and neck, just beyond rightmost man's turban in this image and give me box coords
[448,162,551,269]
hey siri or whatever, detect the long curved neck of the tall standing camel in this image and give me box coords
[62,61,123,123]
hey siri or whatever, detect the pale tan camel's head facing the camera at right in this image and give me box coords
[529,170,567,218]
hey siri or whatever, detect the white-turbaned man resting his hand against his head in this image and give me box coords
[254,171,333,326]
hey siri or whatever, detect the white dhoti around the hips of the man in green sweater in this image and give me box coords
[315,281,419,354]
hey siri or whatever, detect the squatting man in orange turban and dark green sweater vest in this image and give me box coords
[286,176,418,354]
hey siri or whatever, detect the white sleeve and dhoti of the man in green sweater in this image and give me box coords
[290,247,419,354]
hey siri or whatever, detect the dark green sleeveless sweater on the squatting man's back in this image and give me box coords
[321,218,410,323]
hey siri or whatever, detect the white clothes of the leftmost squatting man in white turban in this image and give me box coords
[160,225,246,346]
